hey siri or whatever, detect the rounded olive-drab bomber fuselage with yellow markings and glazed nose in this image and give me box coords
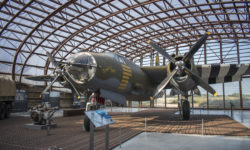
[67,52,155,100]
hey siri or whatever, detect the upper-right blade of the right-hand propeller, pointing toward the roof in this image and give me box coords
[182,32,210,62]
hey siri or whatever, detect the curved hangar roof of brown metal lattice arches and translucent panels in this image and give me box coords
[0,0,250,87]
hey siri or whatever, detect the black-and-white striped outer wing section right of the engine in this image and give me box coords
[196,64,250,84]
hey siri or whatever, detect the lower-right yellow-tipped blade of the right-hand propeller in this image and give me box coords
[184,66,217,96]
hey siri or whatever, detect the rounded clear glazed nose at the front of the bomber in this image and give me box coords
[66,52,97,84]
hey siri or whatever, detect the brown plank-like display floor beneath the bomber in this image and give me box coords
[0,108,250,150]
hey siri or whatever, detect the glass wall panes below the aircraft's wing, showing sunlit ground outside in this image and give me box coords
[128,78,250,109]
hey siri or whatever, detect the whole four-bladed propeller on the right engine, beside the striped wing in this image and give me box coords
[148,32,217,100]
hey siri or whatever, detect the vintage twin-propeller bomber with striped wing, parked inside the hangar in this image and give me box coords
[26,32,250,130]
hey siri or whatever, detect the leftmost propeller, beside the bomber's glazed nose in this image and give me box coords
[41,51,80,99]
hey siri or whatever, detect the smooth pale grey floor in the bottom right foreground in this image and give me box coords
[113,132,250,150]
